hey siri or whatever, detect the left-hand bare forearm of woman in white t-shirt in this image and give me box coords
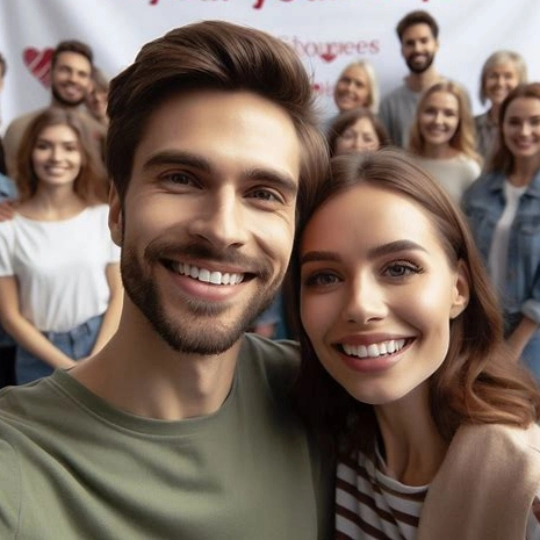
[0,276,75,369]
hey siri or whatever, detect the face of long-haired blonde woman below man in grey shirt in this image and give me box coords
[418,92,459,150]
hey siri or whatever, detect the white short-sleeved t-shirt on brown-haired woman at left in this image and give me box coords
[0,204,120,332]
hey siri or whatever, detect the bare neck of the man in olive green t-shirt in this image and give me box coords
[70,306,242,421]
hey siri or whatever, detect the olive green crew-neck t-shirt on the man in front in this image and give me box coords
[0,335,332,540]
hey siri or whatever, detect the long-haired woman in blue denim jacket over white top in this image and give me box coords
[463,83,540,381]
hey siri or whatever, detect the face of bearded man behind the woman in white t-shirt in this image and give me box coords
[51,52,92,107]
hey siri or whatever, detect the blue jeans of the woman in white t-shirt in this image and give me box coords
[15,315,103,384]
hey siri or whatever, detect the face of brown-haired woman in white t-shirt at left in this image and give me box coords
[32,124,82,186]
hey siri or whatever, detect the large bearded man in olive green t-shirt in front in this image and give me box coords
[0,22,331,540]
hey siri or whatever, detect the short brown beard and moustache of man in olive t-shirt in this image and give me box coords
[120,243,283,356]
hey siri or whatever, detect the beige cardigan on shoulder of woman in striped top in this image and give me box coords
[418,424,540,540]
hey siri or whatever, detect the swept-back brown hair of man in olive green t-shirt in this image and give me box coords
[106,21,328,221]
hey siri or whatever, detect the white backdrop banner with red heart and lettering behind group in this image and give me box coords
[0,0,540,130]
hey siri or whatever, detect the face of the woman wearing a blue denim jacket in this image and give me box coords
[502,97,540,159]
